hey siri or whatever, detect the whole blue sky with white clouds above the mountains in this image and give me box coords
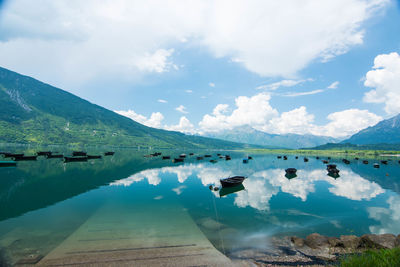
[0,0,400,138]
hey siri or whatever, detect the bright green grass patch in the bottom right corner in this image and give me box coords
[340,247,400,267]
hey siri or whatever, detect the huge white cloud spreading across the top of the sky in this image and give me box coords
[0,0,389,88]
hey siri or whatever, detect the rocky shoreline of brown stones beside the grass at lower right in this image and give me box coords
[229,233,400,266]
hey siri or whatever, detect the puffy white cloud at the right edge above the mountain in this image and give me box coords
[364,52,400,115]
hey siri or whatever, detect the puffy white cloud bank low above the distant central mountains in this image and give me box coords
[199,93,382,137]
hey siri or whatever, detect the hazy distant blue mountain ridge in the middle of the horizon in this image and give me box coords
[203,126,337,149]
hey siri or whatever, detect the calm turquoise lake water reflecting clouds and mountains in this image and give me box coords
[0,149,400,262]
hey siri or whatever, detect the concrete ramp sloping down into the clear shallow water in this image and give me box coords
[37,200,233,266]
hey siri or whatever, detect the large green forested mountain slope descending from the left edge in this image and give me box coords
[0,68,250,148]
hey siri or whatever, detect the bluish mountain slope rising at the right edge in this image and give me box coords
[342,114,400,145]
